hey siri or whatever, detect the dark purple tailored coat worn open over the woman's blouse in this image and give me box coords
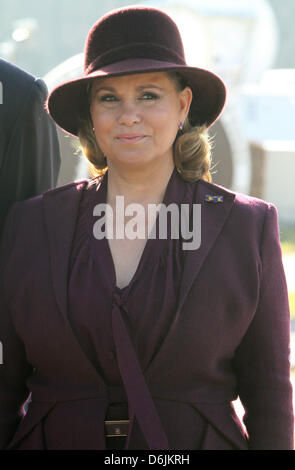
[0,175,293,450]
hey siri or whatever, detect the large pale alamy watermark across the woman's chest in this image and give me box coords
[93,196,201,250]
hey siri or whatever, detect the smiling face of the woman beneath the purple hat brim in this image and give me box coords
[90,72,192,170]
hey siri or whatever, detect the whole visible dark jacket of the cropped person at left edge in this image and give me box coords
[0,59,61,236]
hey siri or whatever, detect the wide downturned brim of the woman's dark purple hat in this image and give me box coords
[46,59,226,136]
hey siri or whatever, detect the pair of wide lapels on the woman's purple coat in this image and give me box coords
[43,171,235,367]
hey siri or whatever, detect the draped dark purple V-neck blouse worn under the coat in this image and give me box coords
[68,169,205,448]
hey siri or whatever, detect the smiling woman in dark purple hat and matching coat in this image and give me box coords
[0,6,293,450]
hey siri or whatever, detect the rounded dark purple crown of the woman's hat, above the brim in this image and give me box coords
[84,6,186,74]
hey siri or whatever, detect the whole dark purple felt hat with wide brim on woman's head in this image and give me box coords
[46,5,226,136]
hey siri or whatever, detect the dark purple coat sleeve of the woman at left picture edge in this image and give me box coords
[0,203,33,449]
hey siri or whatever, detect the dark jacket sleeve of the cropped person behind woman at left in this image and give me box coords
[0,79,61,237]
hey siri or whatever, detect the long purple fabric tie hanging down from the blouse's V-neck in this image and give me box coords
[112,302,169,450]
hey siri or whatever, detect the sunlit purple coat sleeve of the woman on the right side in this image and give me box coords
[235,204,294,450]
